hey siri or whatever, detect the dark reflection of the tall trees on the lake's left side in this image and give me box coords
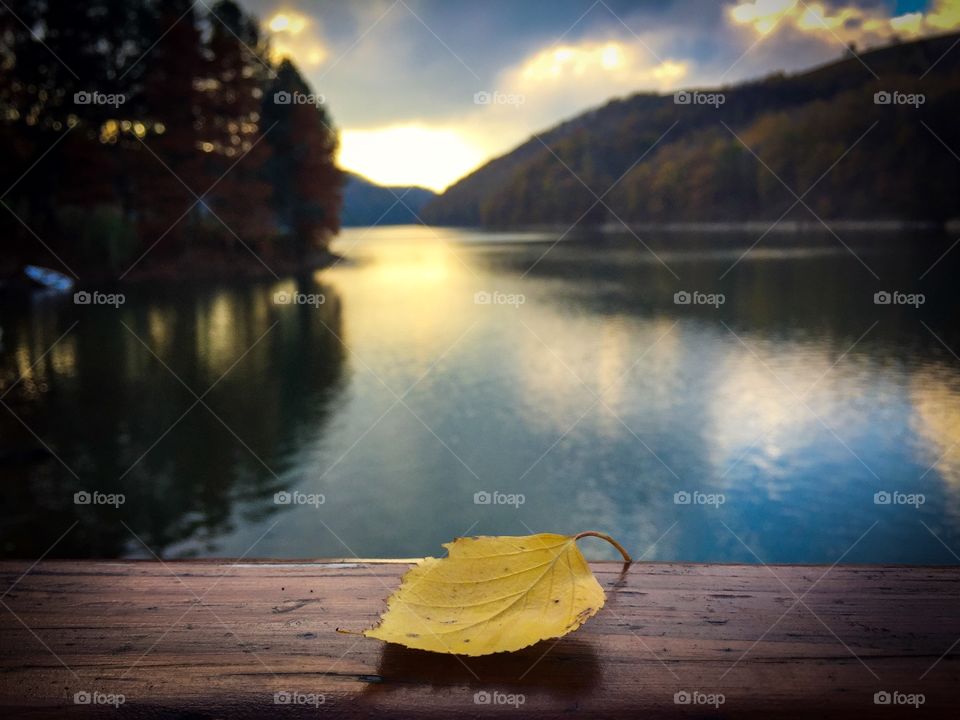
[0,286,344,557]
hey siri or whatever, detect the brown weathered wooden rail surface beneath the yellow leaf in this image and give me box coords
[0,561,960,718]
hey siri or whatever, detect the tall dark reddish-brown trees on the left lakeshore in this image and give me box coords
[0,0,343,277]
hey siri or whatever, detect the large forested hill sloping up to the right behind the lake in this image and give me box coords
[423,34,960,225]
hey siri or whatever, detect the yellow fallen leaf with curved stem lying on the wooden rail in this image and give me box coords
[363,531,630,655]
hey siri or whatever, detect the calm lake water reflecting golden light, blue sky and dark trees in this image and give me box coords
[0,228,960,563]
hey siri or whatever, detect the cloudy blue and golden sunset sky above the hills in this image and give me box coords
[241,0,960,190]
